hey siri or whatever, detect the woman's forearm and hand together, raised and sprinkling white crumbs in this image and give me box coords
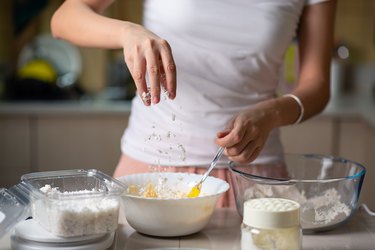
[51,0,176,106]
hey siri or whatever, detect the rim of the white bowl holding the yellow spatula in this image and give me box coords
[116,172,230,201]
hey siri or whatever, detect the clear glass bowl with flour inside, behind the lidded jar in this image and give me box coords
[229,154,366,233]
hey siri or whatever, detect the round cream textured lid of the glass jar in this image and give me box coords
[243,198,300,229]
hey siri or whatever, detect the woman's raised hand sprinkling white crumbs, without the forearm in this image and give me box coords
[123,23,176,106]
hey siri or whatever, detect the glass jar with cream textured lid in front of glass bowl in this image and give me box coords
[241,198,302,250]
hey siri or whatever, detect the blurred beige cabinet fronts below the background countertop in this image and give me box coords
[0,112,375,209]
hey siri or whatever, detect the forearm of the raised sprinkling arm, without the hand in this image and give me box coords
[51,0,135,49]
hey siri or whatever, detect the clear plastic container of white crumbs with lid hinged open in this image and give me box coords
[0,169,125,237]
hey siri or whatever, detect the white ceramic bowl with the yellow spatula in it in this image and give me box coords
[118,172,229,237]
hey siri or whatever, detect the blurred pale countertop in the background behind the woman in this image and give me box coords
[0,85,375,128]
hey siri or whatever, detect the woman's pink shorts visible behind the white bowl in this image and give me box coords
[113,155,236,208]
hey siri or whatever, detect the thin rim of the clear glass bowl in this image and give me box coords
[228,153,366,185]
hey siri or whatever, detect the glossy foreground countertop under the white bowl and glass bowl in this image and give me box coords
[0,209,375,250]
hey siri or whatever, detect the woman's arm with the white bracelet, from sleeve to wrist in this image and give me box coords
[260,0,336,127]
